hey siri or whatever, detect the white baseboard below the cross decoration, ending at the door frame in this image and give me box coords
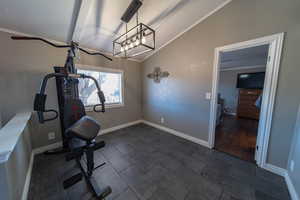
[142,120,210,148]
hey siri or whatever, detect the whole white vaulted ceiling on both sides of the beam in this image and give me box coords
[0,0,226,60]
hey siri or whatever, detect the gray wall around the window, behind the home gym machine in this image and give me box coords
[0,32,141,148]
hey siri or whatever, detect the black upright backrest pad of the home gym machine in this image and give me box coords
[64,99,86,129]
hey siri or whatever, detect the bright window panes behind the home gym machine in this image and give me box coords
[77,67,123,107]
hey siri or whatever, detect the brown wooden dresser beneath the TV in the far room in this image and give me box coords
[237,89,262,120]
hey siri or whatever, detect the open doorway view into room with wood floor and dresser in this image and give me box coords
[215,44,269,162]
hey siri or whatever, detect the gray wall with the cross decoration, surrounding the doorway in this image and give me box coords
[142,0,300,168]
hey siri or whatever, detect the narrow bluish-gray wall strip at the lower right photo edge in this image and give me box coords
[288,106,300,197]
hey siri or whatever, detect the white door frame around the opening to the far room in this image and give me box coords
[208,33,284,167]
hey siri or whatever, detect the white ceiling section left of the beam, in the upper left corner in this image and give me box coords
[0,0,75,41]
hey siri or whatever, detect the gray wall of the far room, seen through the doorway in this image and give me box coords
[219,68,266,113]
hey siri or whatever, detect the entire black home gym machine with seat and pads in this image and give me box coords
[11,36,112,199]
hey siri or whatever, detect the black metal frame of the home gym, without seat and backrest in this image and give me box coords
[11,36,112,199]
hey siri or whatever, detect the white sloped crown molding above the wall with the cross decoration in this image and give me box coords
[141,0,232,62]
